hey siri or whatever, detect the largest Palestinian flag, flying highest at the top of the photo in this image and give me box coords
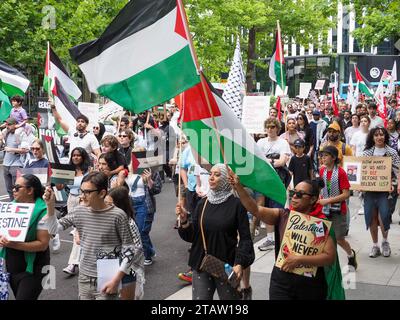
[70,0,200,113]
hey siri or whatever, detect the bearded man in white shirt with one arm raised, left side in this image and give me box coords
[51,105,101,158]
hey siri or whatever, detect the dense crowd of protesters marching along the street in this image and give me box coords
[0,0,400,300]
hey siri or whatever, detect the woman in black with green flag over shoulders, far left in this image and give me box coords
[0,174,50,300]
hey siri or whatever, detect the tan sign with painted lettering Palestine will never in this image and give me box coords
[275,211,332,277]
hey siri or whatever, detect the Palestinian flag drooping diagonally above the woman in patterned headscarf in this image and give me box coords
[183,75,286,205]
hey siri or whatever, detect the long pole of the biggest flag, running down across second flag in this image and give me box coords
[177,0,228,167]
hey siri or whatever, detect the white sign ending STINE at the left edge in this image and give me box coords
[0,202,35,242]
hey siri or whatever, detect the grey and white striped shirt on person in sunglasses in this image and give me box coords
[58,206,134,277]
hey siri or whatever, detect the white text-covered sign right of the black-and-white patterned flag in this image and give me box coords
[242,96,270,134]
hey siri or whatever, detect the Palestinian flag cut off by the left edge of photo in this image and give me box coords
[0,60,30,97]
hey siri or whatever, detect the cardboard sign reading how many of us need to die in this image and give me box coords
[343,156,392,192]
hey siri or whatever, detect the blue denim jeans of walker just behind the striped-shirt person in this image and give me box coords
[133,196,155,259]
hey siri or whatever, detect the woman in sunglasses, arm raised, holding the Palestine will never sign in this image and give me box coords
[229,171,344,300]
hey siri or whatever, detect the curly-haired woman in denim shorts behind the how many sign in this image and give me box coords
[363,127,400,258]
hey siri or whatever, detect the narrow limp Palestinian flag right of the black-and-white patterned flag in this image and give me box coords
[269,23,286,92]
